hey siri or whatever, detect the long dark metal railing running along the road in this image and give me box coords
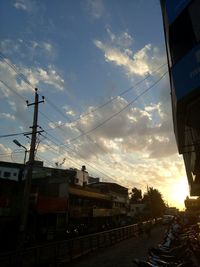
[0,220,161,267]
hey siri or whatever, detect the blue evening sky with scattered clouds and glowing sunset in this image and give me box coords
[0,0,189,209]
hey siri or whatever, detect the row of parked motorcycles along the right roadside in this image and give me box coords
[133,217,200,267]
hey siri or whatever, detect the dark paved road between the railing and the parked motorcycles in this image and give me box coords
[67,226,165,267]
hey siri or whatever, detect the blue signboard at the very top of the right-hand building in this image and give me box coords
[165,0,191,24]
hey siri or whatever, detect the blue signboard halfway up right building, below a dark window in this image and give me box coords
[172,45,200,101]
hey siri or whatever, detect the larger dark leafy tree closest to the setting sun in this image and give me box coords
[143,187,166,218]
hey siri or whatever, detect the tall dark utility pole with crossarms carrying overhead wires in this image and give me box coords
[20,88,44,245]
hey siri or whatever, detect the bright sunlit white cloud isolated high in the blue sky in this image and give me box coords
[94,29,165,76]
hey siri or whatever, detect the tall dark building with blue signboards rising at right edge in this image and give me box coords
[161,0,200,196]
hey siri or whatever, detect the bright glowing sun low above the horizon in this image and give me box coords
[168,177,189,210]
